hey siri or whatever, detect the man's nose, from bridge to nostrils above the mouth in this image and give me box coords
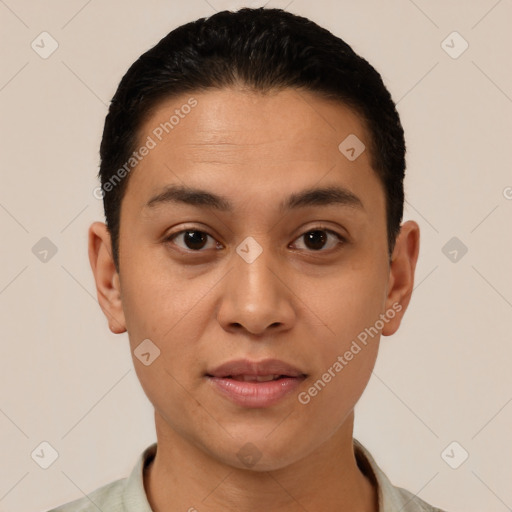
[217,240,296,335]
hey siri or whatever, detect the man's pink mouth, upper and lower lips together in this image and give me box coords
[205,359,307,408]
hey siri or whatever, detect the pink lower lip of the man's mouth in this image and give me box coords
[208,376,305,408]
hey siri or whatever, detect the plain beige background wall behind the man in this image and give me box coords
[0,0,512,512]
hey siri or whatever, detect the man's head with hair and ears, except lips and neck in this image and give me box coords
[90,9,419,469]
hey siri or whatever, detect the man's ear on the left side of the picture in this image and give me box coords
[89,222,126,334]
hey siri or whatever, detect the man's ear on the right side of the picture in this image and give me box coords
[382,220,420,336]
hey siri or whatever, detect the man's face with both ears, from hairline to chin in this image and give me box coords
[90,89,417,470]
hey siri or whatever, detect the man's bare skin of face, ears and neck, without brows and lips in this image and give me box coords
[89,88,419,512]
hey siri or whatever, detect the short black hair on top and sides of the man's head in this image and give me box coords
[99,8,405,270]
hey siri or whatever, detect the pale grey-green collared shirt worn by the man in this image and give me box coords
[48,439,444,512]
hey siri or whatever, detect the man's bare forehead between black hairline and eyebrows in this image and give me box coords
[125,89,377,216]
